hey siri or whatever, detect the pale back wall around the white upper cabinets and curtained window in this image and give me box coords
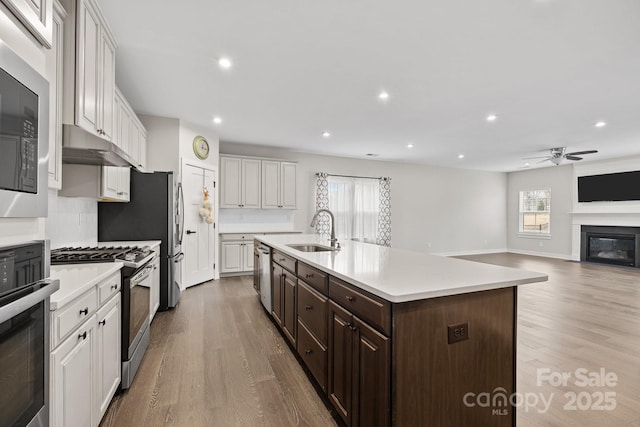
[220,142,507,253]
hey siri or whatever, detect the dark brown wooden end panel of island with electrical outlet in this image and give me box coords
[391,287,517,427]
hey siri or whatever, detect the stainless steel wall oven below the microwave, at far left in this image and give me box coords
[0,243,59,426]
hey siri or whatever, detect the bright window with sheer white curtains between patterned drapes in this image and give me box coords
[327,176,380,243]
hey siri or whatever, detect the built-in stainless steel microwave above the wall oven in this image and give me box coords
[0,40,49,217]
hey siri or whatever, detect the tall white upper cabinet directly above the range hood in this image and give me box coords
[63,0,116,141]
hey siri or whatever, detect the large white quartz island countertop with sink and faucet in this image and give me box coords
[256,234,548,303]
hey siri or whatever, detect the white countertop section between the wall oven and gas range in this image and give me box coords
[50,262,123,311]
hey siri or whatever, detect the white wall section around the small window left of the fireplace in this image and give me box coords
[507,164,573,258]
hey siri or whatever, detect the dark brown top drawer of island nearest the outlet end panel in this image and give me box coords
[329,277,391,335]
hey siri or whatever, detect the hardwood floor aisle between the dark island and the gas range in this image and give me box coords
[101,276,336,427]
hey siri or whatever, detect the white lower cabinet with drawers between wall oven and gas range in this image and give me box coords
[49,272,121,427]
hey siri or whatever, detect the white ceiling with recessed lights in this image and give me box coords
[99,0,640,171]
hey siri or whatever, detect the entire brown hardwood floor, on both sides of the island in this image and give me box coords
[101,254,640,427]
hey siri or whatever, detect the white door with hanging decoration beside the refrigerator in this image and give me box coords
[182,164,217,288]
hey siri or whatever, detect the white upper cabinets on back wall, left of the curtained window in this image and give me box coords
[220,156,297,209]
